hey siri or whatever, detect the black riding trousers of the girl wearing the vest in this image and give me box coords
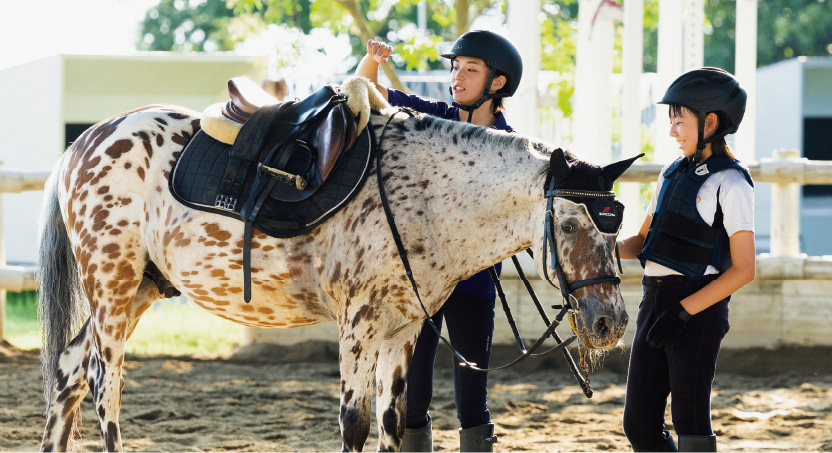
[624,276,730,450]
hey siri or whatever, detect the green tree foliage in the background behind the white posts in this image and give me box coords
[138,0,832,117]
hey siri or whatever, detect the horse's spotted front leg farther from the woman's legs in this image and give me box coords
[338,305,382,451]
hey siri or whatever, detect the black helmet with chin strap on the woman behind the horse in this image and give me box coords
[442,30,523,122]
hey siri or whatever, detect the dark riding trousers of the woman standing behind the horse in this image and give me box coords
[405,291,494,428]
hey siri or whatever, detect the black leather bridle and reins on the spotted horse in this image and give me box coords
[376,108,621,398]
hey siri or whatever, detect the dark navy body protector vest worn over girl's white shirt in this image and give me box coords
[638,157,754,280]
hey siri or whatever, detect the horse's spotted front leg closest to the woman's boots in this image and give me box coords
[376,322,422,451]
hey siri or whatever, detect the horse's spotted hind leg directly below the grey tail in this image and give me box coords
[41,319,92,451]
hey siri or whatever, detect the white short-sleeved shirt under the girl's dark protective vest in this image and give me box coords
[644,161,754,277]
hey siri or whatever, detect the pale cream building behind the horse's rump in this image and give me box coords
[0,52,268,264]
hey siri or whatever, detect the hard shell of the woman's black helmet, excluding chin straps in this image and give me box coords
[442,30,523,96]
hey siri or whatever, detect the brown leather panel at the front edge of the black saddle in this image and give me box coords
[316,103,357,181]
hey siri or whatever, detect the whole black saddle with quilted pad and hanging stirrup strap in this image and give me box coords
[168,79,374,302]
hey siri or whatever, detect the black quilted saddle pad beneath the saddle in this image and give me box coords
[168,122,375,238]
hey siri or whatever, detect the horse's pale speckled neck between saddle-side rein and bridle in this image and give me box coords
[387,116,545,286]
